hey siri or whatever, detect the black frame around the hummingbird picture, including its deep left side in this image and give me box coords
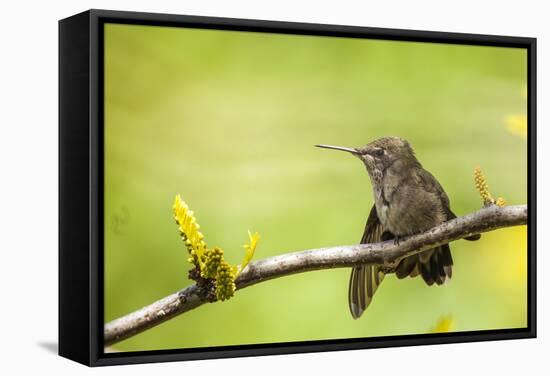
[59,10,536,366]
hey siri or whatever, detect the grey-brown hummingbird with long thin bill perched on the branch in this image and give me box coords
[315,137,480,319]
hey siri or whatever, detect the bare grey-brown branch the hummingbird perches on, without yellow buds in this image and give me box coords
[104,205,527,346]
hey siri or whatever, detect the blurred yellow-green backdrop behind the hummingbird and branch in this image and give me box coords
[105,24,527,351]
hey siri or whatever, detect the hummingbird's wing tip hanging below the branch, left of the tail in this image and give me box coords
[348,265,385,319]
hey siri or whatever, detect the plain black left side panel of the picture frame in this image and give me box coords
[58,11,93,365]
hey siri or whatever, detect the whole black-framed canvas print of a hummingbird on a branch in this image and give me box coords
[59,10,536,366]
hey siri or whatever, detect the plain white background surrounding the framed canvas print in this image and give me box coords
[0,0,550,375]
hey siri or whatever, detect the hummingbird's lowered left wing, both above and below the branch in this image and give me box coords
[348,206,391,319]
